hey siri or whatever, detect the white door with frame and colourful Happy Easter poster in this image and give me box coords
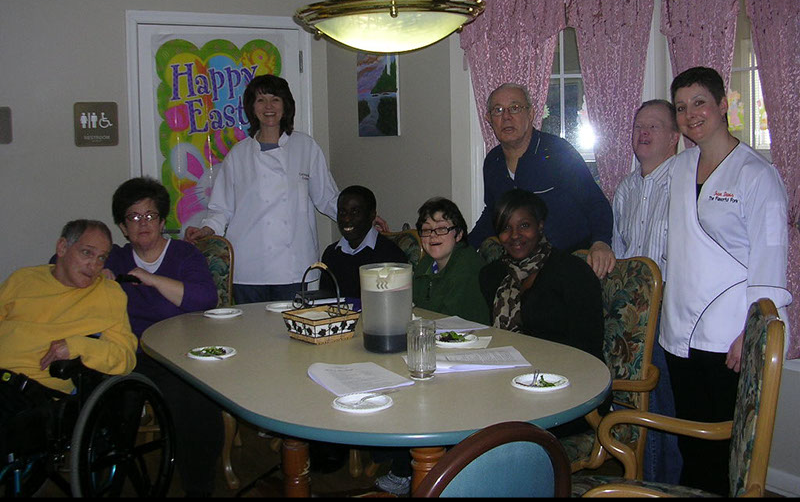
[126,11,312,236]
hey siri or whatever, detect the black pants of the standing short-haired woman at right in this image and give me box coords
[666,349,739,496]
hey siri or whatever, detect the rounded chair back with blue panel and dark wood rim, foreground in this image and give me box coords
[413,422,571,497]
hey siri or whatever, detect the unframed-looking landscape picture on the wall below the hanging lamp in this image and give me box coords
[356,52,400,137]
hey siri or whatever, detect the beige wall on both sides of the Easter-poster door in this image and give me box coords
[0,0,468,280]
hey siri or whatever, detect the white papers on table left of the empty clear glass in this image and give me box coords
[308,362,414,396]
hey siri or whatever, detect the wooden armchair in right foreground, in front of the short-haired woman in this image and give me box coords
[573,298,785,497]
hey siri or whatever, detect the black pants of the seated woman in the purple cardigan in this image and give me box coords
[134,352,224,496]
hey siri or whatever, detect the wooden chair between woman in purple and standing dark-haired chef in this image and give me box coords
[195,235,242,490]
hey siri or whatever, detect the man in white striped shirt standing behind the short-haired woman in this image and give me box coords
[612,99,682,483]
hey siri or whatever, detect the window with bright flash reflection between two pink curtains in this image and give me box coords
[542,28,595,162]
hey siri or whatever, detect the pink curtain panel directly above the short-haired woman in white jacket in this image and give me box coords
[661,0,739,89]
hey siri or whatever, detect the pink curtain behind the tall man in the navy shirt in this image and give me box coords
[461,0,566,151]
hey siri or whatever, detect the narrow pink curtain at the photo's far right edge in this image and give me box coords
[746,0,800,359]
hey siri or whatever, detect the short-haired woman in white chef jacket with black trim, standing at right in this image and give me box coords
[659,67,792,495]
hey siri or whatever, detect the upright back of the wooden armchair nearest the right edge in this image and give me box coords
[729,298,785,497]
